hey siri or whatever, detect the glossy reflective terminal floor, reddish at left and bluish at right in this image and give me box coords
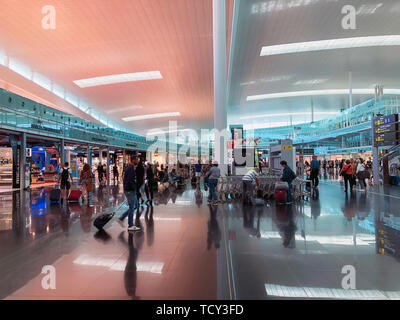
[0,176,400,299]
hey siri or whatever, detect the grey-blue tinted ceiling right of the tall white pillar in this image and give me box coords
[228,0,400,124]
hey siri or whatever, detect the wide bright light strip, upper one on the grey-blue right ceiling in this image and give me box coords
[260,35,400,57]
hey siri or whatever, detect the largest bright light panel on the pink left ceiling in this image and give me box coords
[74,71,162,88]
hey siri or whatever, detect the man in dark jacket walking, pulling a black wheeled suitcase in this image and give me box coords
[117,156,140,231]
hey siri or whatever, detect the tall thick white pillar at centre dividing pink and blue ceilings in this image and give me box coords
[213,0,227,175]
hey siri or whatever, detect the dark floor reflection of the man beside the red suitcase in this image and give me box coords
[275,205,297,248]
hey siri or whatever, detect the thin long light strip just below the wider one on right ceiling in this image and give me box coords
[246,89,400,101]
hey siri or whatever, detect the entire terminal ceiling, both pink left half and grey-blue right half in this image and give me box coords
[0,0,400,134]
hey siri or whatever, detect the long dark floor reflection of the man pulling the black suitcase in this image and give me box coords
[118,232,143,300]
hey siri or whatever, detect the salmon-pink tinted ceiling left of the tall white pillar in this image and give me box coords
[0,0,233,134]
